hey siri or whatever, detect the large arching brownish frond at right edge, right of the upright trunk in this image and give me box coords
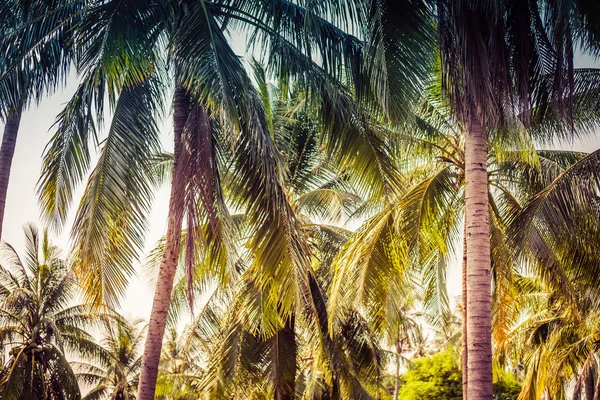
[509,152,598,296]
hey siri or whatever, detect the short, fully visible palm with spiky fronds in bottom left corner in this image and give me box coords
[0,226,101,400]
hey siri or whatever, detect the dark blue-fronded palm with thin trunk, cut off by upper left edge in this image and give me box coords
[0,0,79,237]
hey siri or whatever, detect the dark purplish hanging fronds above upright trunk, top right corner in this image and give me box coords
[435,0,599,126]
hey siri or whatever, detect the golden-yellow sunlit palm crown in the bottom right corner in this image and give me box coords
[497,276,599,400]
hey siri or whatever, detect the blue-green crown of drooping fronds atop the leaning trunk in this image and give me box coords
[25,0,431,310]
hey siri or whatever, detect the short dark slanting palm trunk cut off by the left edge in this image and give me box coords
[0,107,22,239]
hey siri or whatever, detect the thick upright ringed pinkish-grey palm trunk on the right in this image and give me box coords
[465,116,493,400]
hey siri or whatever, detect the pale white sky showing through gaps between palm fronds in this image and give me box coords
[0,40,600,320]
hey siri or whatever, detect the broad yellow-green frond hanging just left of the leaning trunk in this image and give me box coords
[72,81,162,305]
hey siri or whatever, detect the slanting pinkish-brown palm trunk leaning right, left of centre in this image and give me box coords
[137,88,190,400]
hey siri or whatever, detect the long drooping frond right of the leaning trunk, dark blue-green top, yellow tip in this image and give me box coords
[175,2,308,324]
